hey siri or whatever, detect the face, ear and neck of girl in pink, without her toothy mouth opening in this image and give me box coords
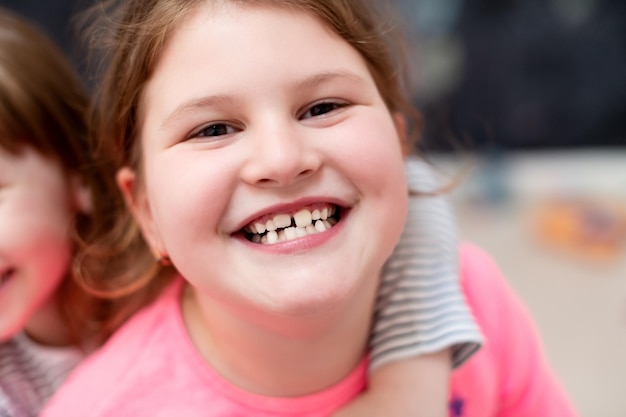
[118,5,407,396]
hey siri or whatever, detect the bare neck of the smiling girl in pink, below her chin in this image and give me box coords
[183,280,377,397]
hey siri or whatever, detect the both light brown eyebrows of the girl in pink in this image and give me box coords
[161,70,366,128]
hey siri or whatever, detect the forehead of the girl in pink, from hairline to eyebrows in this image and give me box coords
[143,6,371,105]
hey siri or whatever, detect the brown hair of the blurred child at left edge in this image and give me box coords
[0,8,117,344]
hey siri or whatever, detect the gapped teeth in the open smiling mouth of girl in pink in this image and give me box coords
[242,204,341,245]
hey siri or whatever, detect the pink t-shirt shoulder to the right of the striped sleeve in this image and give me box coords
[457,244,576,417]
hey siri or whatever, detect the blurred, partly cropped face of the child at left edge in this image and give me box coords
[0,148,71,341]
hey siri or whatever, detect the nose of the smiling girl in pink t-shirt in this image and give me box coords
[242,122,321,187]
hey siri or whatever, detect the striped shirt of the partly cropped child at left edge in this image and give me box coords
[0,333,82,417]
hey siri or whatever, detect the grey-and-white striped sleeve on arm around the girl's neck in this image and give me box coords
[370,158,482,369]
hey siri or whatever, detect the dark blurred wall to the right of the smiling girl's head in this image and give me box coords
[396,0,626,150]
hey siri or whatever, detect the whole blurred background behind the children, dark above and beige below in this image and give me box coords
[0,0,626,417]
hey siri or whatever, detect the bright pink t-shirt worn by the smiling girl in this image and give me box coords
[42,245,576,417]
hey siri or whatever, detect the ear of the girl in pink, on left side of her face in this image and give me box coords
[116,167,167,260]
